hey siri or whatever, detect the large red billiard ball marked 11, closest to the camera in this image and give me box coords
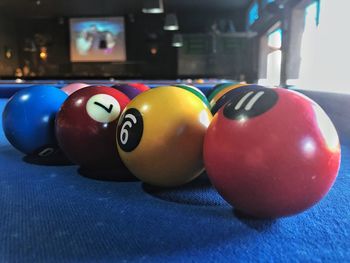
[204,87,340,218]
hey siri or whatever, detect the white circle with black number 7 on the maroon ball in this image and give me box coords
[86,94,120,123]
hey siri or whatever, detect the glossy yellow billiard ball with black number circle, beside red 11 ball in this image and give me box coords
[117,87,212,187]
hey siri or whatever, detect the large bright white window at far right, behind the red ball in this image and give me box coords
[295,0,350,93]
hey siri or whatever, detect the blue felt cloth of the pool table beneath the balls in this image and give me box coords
[0,91,350,262]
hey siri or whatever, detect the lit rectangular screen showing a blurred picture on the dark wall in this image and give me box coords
[70,17,126,62]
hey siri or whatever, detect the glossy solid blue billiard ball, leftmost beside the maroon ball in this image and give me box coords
[2,85,67,157]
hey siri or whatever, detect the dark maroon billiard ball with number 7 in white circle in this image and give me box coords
[56,86,130,169]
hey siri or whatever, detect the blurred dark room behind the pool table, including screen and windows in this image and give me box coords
[0,0,350,92]
